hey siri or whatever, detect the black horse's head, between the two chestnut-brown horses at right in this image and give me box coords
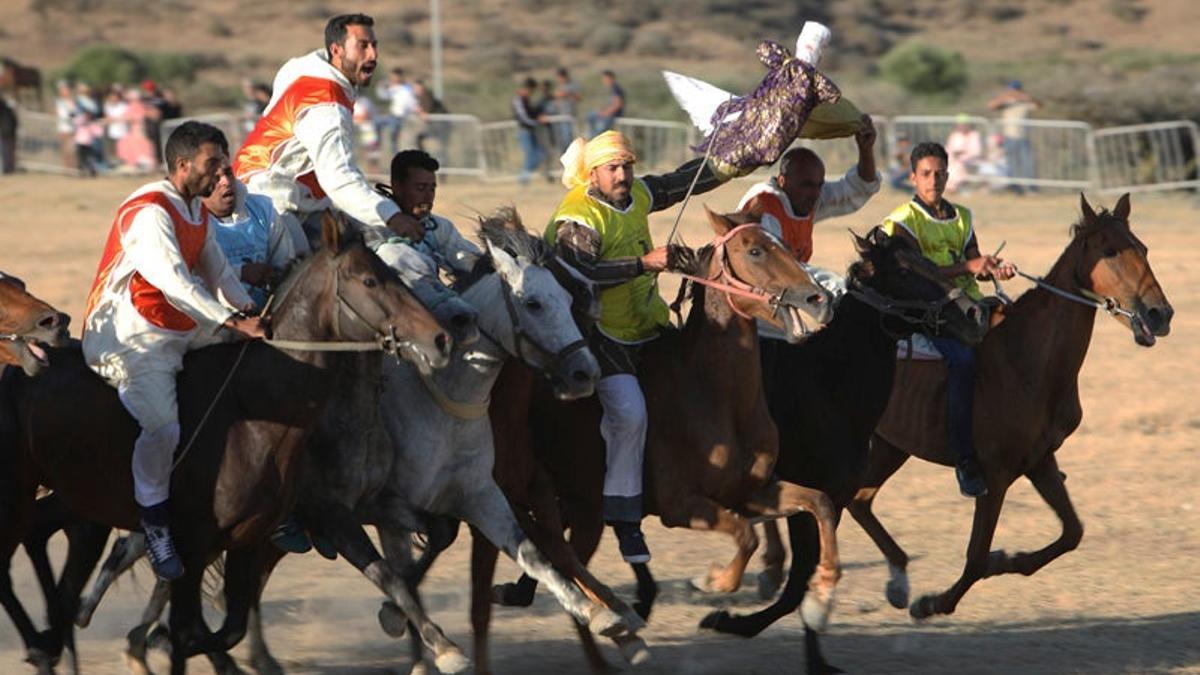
[846,226,988,345]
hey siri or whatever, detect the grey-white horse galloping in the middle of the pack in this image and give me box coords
[75,214,647,673]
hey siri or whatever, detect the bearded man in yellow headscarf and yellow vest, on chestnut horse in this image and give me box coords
[546,131,722,562]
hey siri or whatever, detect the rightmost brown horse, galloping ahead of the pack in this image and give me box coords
[850,195,1174,619]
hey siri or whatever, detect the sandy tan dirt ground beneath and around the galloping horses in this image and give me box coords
[0,175,1200,675]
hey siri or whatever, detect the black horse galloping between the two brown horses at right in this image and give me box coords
[701,228,986,673]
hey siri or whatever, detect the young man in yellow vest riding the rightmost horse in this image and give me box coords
[883,143,1016,497]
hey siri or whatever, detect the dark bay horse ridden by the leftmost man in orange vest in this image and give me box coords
[0,217,450,673]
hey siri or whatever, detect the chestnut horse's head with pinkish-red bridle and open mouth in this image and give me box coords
[704,208,833,342]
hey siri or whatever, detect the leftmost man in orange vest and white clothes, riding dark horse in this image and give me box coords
[83,121,264,580]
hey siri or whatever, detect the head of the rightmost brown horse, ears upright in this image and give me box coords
[1072,193,1175,347]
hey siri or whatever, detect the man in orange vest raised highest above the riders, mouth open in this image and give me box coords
[233,14,424,251]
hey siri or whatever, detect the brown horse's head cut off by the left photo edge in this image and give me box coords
[0,273,71,377]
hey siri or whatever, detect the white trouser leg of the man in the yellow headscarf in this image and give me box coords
[596,375,647,497]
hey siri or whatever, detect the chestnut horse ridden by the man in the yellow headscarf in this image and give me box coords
[472,207,841,669]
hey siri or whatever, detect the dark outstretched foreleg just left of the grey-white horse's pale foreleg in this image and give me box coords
[302,503,469,673]
